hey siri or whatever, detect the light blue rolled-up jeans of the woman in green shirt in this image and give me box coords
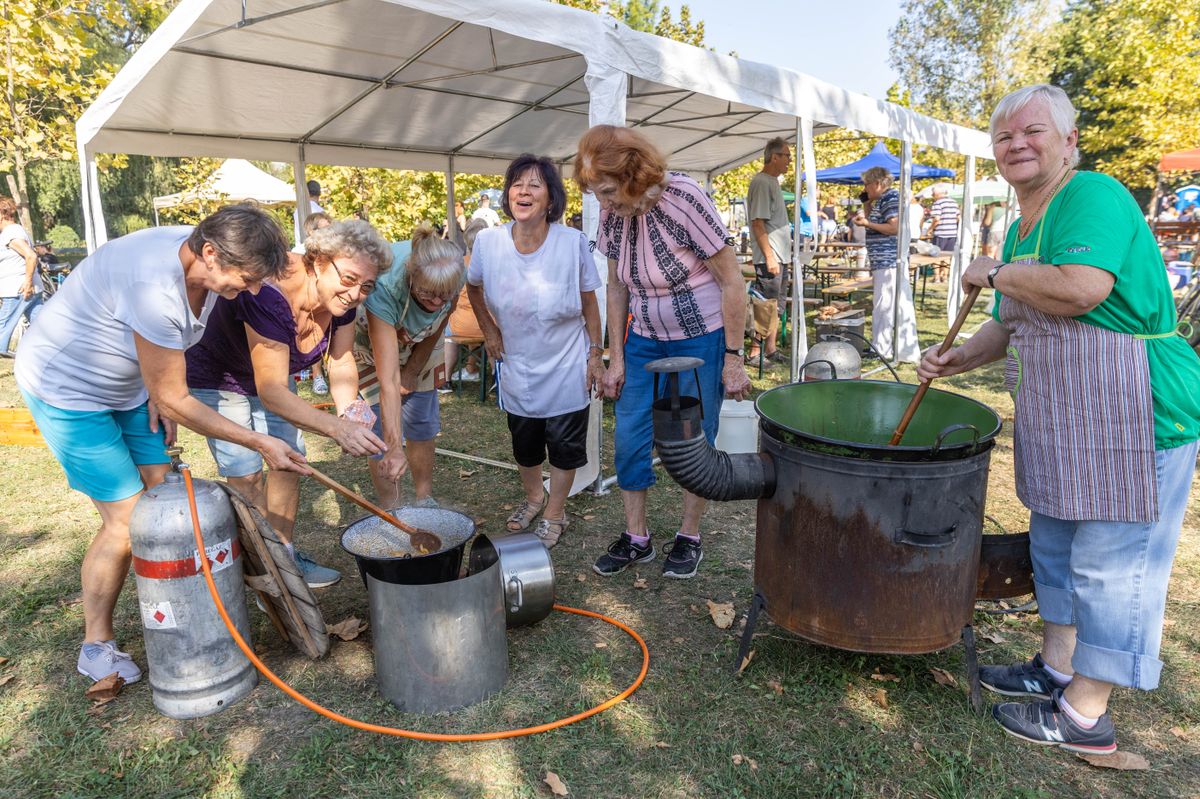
[1030,441,1198,691]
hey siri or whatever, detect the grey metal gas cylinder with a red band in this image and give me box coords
[130,471,258,719]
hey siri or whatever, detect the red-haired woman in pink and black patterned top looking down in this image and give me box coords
[575,125,750,578]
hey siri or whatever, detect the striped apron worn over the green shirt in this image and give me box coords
[998,211,1156,522]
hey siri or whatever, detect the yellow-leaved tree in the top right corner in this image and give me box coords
[1051,0,1200,190]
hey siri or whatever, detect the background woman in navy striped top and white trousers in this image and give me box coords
[854,167,920,364]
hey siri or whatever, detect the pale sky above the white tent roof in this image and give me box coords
[676,0,900,100]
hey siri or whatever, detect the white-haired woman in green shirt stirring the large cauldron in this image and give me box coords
[918,84,1200,753]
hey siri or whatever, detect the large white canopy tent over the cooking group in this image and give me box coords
[77,0,991,491]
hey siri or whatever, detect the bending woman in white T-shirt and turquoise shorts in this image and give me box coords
[14,205,307,683]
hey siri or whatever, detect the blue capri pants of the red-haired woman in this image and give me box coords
[613,329,725,491]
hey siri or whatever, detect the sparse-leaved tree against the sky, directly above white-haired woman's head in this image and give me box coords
[889,0,1055,126]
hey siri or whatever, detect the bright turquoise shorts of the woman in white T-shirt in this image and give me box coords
[20,390,170,503]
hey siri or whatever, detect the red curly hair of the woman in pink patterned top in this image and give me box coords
[574,125,667,205]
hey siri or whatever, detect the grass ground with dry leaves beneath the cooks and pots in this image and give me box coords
[0,287,1200,799]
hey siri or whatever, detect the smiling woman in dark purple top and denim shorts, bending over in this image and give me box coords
[187,221,391,588]
